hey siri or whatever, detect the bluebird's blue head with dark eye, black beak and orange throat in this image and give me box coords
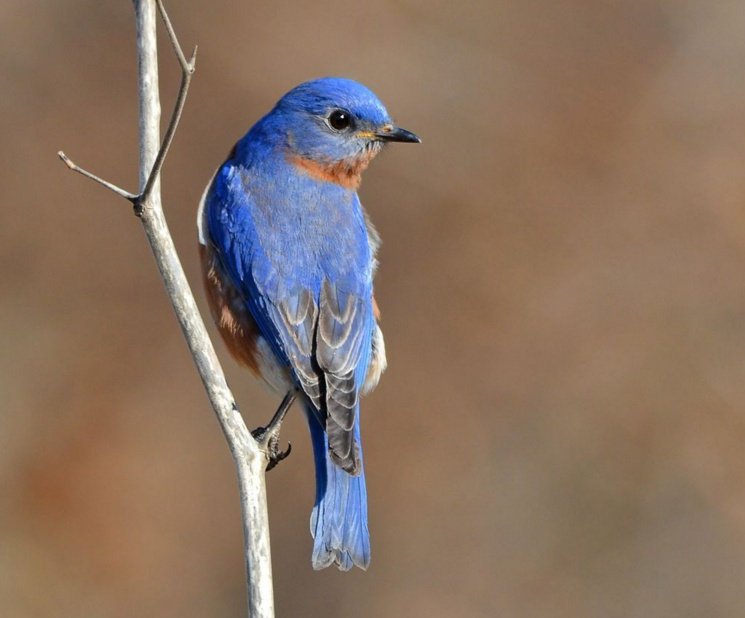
[265,77,421,187]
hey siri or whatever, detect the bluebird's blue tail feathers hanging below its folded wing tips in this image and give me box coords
[306,403,370,571]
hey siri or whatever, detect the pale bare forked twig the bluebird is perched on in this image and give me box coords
[58,0,274,618]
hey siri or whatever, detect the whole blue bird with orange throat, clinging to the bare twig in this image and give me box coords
[197,77,421,571]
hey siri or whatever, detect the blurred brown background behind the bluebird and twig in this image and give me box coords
[0,0,745,618]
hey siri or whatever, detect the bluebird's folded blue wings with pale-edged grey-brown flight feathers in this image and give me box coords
[205,164,374,474]
